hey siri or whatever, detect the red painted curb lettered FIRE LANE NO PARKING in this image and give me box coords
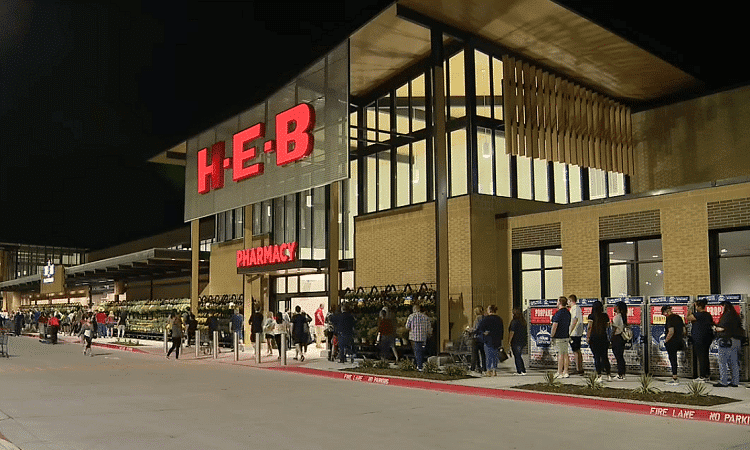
[268,367,750,425]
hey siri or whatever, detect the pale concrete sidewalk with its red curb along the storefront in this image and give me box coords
[48,336,750,426]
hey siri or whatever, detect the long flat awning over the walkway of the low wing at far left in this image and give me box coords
[0,248,210,292]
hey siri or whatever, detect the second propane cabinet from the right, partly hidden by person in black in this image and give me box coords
[648,296,693,377]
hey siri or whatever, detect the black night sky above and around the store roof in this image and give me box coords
[0,0,748,249]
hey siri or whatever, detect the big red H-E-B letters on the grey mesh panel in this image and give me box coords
[198,103,315,194]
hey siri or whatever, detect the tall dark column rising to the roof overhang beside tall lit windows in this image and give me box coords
[430,28,450,351]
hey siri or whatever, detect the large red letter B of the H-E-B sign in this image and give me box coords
[276,103,315,166]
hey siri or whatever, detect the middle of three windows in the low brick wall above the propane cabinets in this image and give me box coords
[602,239,664,297]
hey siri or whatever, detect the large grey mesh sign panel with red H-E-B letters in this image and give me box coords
[184,43,350,222]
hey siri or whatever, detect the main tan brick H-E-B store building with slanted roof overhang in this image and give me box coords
[5,0,750,348]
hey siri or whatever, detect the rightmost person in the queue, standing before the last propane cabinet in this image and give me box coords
[714,301,745,387]
